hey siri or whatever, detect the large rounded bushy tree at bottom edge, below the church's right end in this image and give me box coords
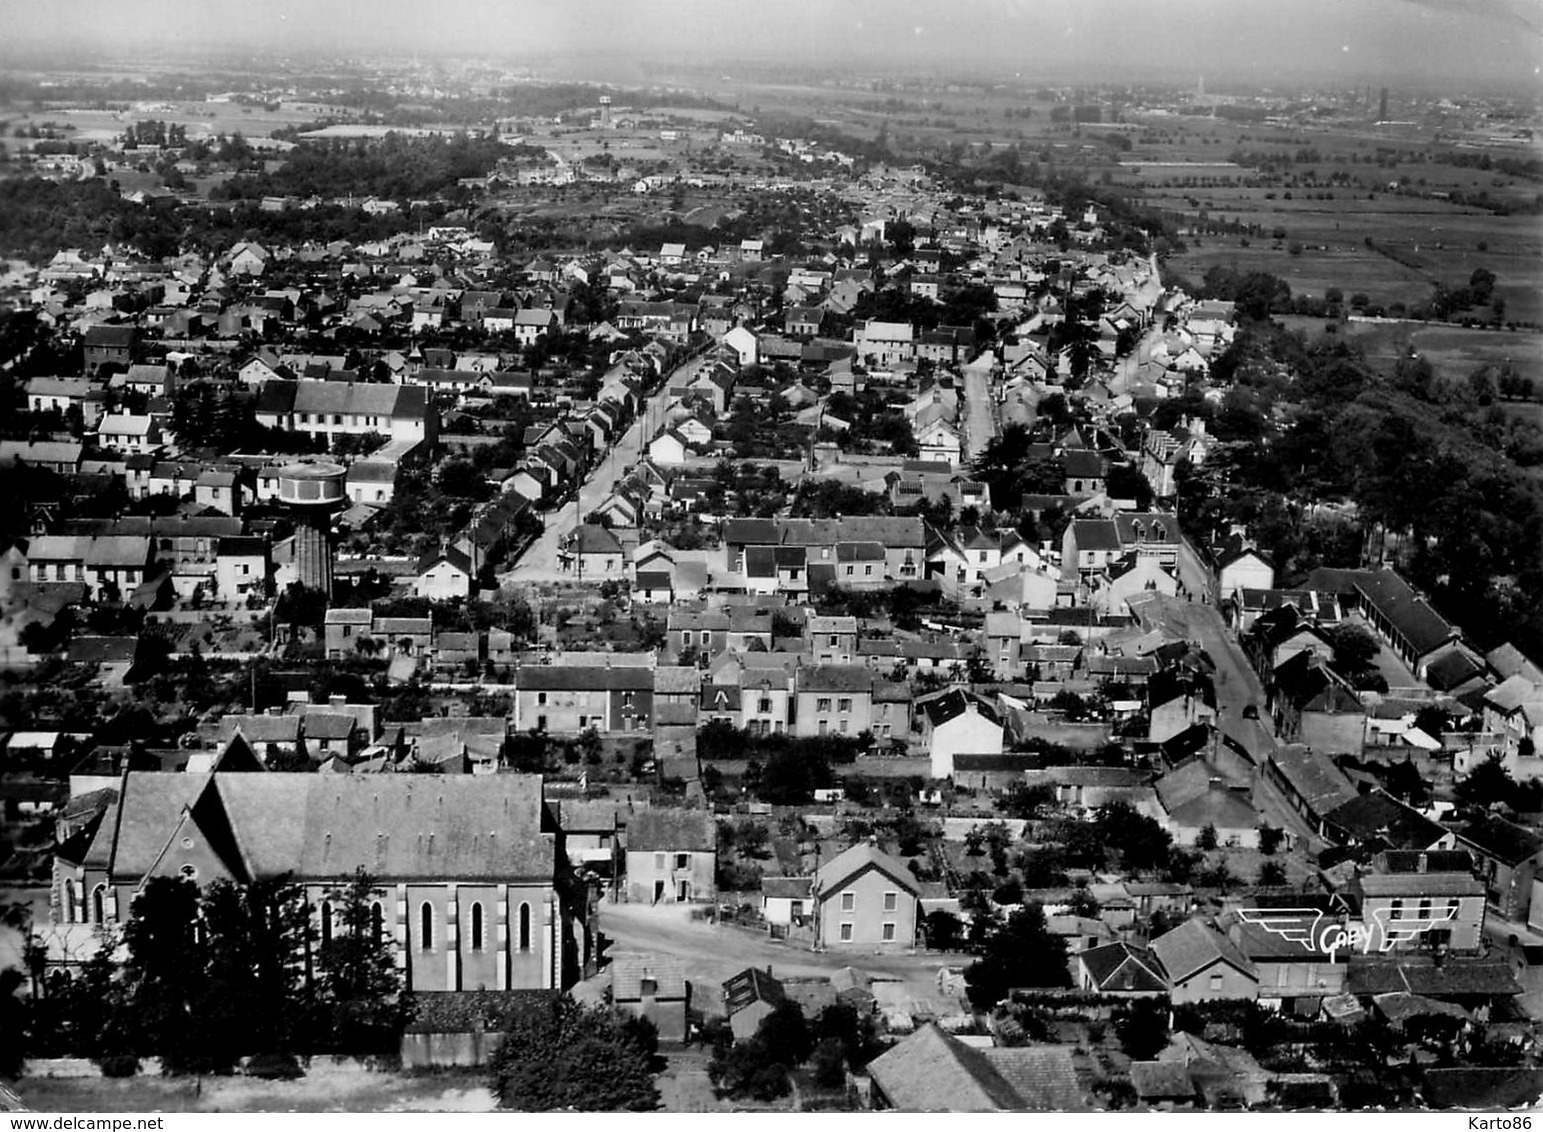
[488,995,659,1112]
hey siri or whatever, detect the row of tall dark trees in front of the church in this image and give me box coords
[25,870,412,1073]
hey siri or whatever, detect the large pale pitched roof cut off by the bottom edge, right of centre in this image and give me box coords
[869,1023,1092,1112]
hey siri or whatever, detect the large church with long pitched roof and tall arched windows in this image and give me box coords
[52,771,591,992]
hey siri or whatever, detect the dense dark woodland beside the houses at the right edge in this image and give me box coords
[1163,308,1543,654]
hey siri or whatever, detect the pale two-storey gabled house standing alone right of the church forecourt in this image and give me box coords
[815,842,921,950]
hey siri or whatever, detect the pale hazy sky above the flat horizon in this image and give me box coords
[9,0,1543,85]
